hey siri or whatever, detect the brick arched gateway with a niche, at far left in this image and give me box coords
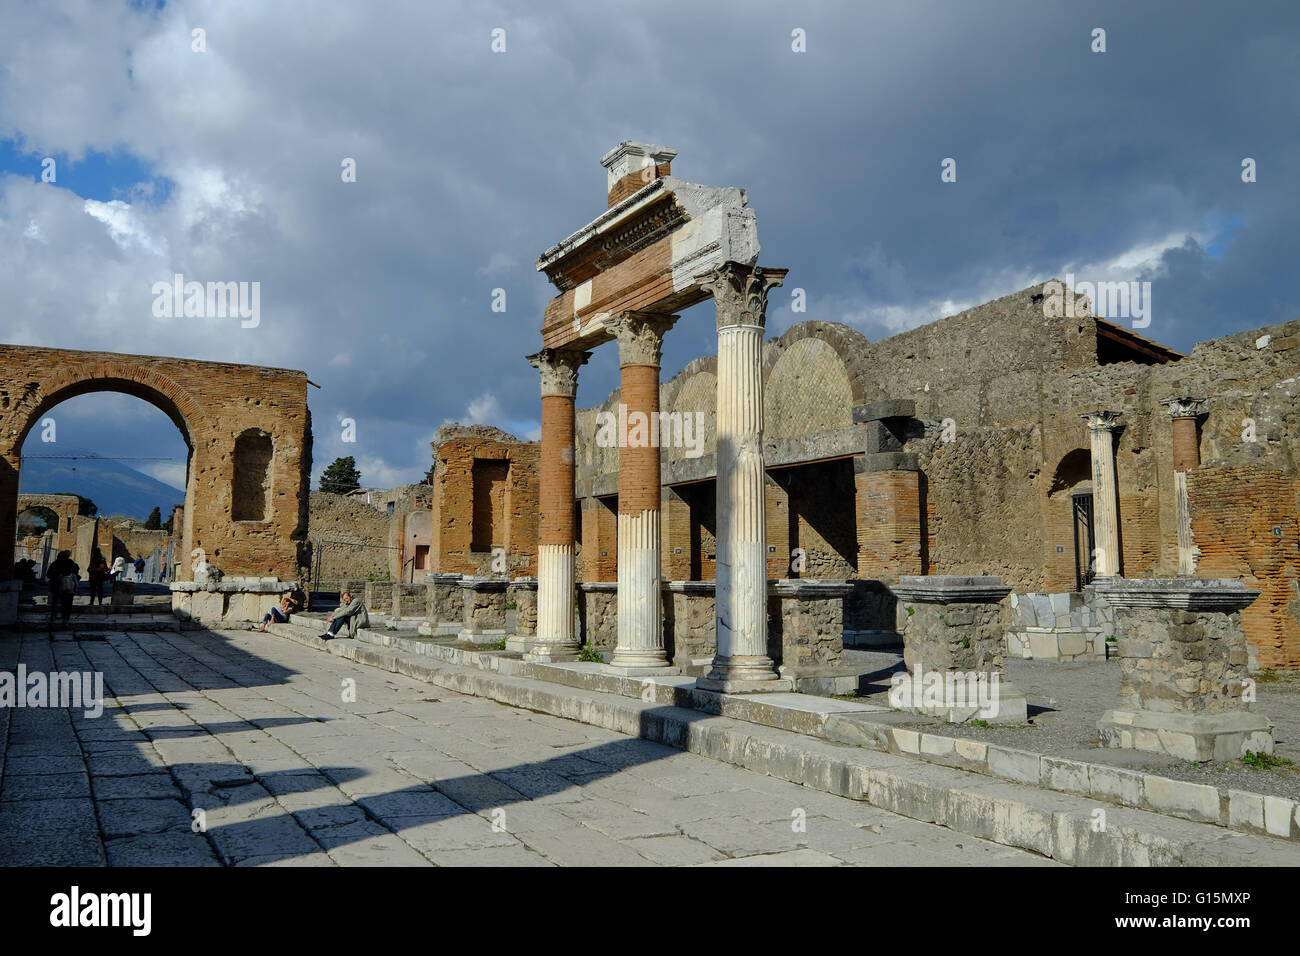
[0,345,312,623]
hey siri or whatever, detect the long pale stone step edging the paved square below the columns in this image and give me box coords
[258,624,1300,866]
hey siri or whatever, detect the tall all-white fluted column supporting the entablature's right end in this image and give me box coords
[698,263,789,693]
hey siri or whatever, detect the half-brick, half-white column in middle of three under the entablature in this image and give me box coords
[610,312,677,671]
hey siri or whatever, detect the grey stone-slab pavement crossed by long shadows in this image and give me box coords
[0,631,1054,866]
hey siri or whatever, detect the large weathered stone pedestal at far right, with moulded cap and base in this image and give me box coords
[1093,578,1273,761]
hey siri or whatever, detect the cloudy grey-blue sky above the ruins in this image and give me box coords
[0,0,1300,486]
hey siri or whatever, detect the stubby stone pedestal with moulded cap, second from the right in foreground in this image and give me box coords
[889,575,1028,723]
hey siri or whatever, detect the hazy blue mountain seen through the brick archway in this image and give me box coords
[18,447,185,522]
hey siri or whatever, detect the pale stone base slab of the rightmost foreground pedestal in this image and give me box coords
[1097,710,1273,761]
